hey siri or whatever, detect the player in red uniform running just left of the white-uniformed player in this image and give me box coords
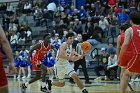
[21,34,53,92]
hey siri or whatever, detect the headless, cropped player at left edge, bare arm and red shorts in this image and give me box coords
[0,26,16,93]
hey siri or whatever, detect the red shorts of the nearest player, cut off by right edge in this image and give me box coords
[127,54,140,73]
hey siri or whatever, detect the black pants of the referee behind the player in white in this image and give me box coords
[70,58,89,82]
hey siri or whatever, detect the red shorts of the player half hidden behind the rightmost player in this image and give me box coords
[119,53,133,68]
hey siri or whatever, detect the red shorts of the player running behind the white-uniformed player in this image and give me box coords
[32,56,41,71]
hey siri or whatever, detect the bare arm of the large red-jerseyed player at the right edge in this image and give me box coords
[119,28,132,59]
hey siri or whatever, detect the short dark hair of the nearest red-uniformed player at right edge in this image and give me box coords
[129,11,140,25]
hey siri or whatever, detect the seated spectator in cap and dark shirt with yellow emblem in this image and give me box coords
[94,48,109,80]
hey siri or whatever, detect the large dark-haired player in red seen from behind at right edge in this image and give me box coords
[118,11,140,93]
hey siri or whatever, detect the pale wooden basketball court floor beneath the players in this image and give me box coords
[8,78,140,93]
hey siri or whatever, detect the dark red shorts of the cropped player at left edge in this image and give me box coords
[0,61,8,87]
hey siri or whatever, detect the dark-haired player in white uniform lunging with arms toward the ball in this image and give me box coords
[52,33,88,93]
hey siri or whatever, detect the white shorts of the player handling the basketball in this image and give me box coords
[55,63,76,80]
